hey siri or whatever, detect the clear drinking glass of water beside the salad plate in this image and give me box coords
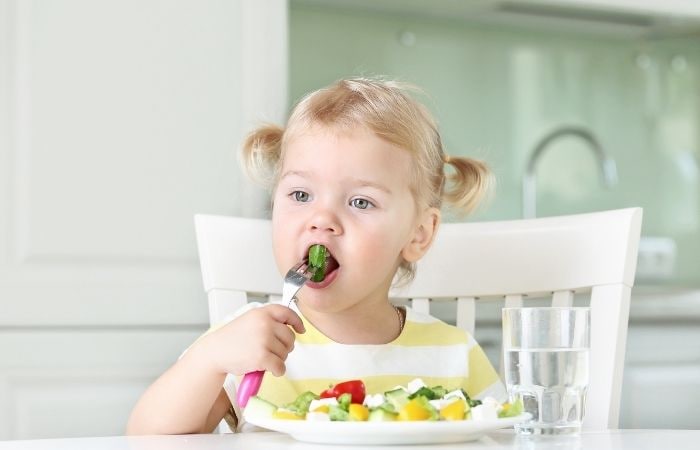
[503,307,590,434]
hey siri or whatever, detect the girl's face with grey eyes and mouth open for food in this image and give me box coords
[272,123,430,312]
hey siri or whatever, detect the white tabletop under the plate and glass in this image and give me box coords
[0,430,700,450]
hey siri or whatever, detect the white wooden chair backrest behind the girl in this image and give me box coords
[195,208,642,430]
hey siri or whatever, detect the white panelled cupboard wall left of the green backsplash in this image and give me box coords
[0,0,287,440]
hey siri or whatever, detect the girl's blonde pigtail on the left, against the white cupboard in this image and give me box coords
[240,124,284,188]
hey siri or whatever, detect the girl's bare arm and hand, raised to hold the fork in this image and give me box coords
[127,305,304,434]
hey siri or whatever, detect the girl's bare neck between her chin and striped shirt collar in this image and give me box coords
[297,301,403,345]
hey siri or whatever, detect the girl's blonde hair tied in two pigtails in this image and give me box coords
[241,78,493,280]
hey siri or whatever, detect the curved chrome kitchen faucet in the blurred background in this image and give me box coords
[523,125,617,219]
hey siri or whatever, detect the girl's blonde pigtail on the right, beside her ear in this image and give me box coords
[443,156,495,214]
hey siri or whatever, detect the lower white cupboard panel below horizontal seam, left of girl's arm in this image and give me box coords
[0,326,204,440]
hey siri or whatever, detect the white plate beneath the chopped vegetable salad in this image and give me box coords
[247,413,530,445]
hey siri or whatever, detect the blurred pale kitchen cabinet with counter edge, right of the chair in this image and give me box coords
[620,286,700,429]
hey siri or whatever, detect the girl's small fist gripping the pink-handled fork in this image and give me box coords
[197,305,305,376]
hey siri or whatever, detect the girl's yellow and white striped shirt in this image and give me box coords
[225,303,506,428]
